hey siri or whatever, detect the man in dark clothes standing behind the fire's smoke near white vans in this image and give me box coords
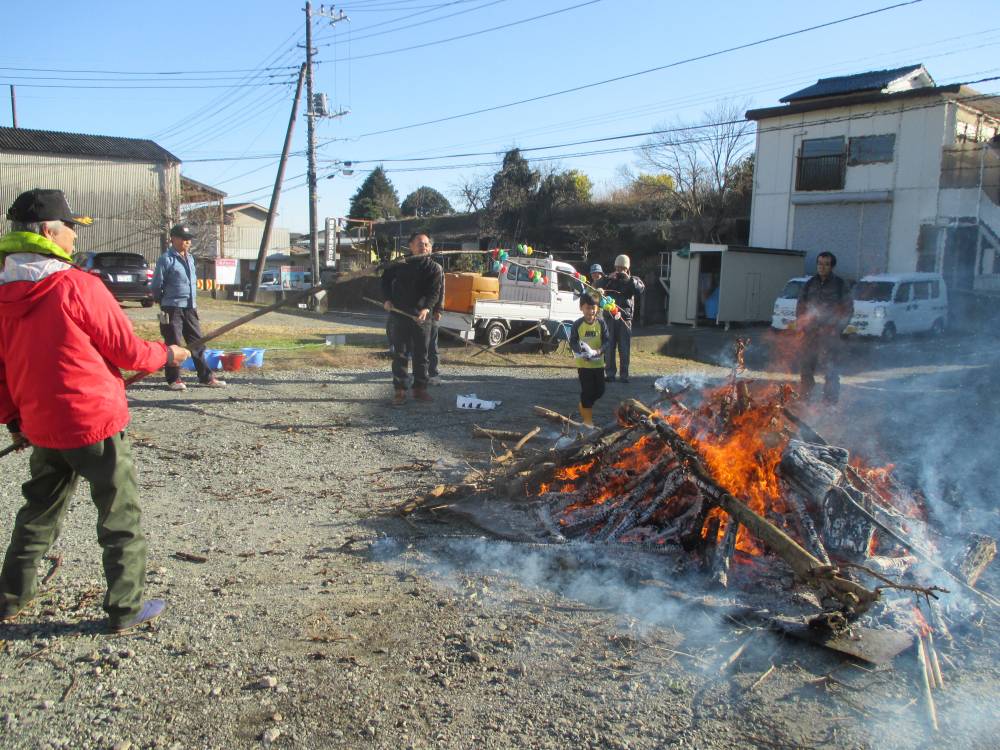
[795,252,851,404]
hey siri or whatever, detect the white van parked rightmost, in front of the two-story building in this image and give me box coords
[844,273,948,341]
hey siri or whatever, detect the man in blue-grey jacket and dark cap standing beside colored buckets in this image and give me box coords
[152,224,226,391]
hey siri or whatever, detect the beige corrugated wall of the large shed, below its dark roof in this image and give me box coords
[0,152,180,262]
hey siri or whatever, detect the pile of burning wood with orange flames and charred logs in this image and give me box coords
[420,362,1000,656]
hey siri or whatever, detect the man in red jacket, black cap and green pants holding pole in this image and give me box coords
[0,189,188,632]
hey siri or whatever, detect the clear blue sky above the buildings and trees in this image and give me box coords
[0,0,1000,231]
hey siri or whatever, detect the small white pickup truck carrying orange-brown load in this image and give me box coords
[438,257,583,346]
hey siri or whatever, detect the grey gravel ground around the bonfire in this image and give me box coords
[0,352,1000,750]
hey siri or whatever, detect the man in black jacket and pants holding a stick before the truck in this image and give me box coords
[382,232,444,406]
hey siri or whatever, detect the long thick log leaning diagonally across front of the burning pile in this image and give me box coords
[620,400,879,616]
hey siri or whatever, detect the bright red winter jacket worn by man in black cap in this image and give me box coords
[0,239,167,450]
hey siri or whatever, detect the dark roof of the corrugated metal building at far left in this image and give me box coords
[0,128,181,164]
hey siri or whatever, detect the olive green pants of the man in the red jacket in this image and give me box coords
[0,432,146,625]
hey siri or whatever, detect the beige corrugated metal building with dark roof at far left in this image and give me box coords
[0,128,181,262]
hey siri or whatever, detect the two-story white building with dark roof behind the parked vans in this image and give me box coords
[746,65,1000,302]
